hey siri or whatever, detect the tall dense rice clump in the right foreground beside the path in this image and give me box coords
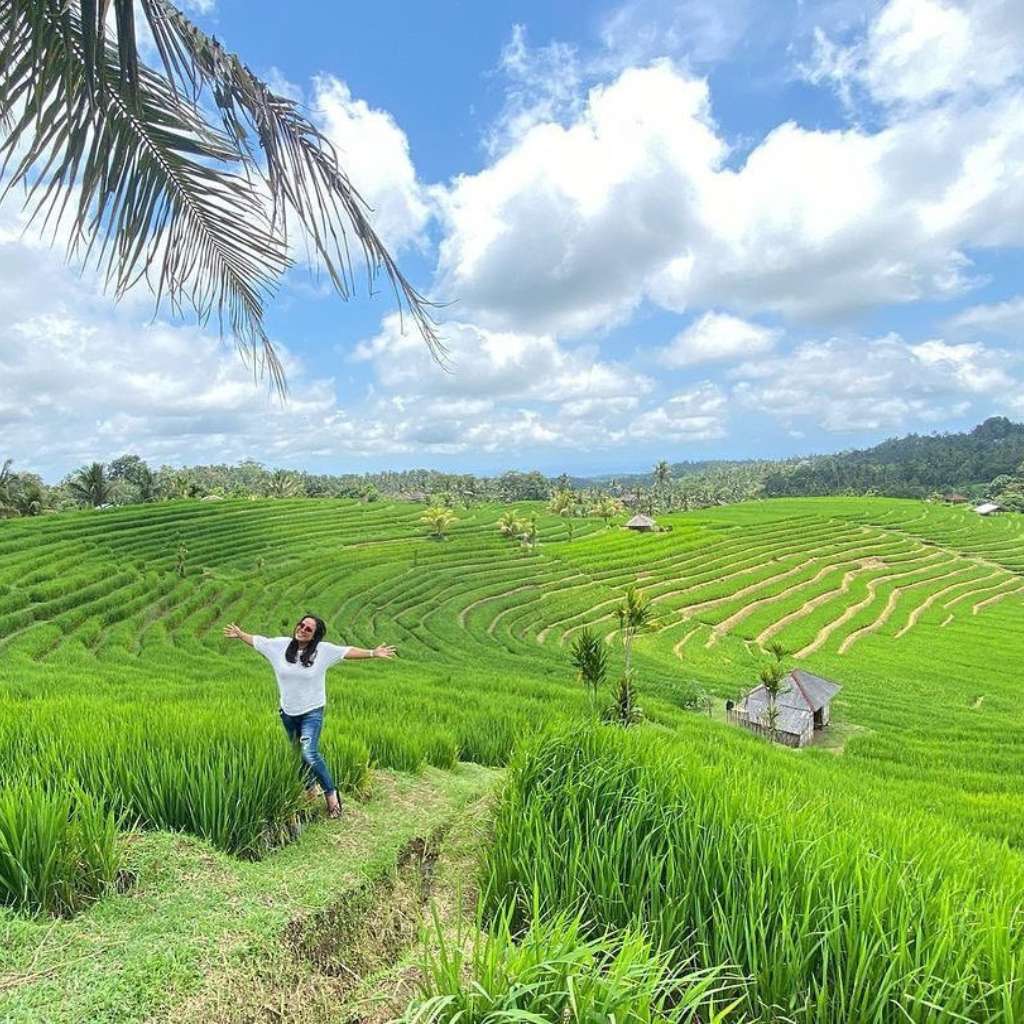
[484,730,1024,1024]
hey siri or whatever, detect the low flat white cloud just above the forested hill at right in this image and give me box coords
[731,335,1024,432]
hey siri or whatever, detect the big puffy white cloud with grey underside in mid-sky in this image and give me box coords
[439,62,725,332]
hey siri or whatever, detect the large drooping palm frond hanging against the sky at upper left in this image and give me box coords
[0,0,443,391]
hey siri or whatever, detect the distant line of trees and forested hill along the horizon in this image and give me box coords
[0,417,1024,519]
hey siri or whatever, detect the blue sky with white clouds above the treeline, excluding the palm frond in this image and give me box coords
[0,0,1024,480]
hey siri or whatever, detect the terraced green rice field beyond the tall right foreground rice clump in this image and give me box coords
[0,499,1024,1020]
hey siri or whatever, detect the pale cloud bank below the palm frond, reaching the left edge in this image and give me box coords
[0,206,373,478]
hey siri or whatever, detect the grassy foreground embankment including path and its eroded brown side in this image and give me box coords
[0,766,495,1024]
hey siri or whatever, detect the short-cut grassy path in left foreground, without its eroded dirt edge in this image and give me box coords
[0,766,495,1024]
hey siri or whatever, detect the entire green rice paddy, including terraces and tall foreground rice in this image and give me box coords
[0,499,1024,1022]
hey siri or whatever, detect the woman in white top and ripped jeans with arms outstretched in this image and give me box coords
[224,615,395,818]
